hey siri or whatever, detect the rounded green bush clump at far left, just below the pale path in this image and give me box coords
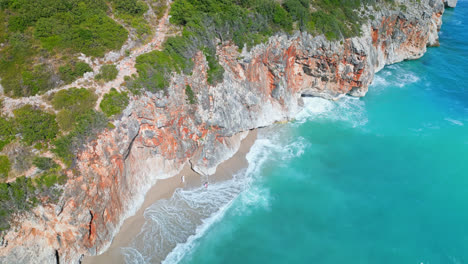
[13,105,58,145]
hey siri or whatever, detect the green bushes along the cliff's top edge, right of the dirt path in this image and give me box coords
[127,0,393,93]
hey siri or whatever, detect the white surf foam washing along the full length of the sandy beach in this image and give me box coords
[122,129,307,264]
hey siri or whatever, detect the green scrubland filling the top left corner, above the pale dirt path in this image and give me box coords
[0,0,127,96]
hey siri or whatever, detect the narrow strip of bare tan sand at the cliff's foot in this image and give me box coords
[81,129,258,264]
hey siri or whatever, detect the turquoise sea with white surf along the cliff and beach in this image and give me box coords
[123,1,468,264]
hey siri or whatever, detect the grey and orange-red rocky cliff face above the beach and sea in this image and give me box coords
[0,0,454,263]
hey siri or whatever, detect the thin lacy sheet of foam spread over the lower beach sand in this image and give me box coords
[123,173,249,263]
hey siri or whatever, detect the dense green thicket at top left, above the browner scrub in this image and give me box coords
[30,0,127,56]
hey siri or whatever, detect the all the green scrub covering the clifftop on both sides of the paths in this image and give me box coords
[0,0,396,231]
